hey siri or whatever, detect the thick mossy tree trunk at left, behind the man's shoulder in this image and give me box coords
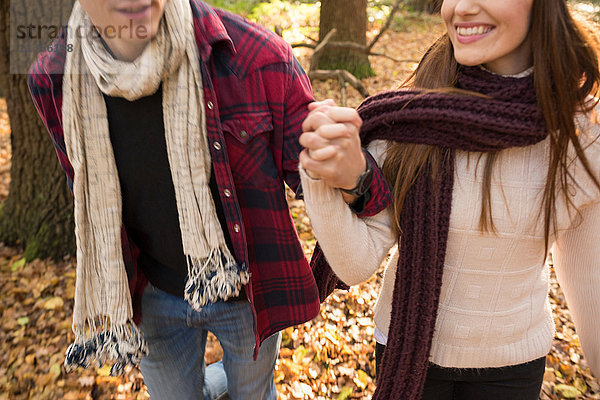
[0,0,75,259]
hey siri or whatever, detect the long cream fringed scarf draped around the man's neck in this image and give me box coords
[62,0,250,374]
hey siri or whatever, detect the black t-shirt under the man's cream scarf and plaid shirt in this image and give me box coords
[104,88,233,297]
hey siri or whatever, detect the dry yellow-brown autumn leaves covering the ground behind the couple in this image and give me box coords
[0,5,600,400]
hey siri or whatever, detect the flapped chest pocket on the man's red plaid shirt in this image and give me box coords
[221,112,280,187]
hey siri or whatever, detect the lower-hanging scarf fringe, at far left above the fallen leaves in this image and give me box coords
[65,318,148,376]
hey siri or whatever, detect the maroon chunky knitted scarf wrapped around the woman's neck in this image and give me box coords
[313,67,547,400]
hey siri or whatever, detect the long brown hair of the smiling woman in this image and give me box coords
[383,0,600,250]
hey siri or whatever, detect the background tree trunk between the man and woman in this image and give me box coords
[318,0,375,79]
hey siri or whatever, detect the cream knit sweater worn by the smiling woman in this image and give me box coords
[300,106,600,375]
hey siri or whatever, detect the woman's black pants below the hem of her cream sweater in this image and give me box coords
[375,343,546,400]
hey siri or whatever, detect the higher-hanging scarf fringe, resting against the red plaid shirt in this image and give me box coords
[184,248,250,311]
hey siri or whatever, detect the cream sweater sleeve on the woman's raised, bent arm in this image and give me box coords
[300,142,395,285]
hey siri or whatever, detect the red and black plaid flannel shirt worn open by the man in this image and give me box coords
[28,0,389,350]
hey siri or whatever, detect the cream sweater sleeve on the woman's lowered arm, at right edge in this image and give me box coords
[552,203,600,378]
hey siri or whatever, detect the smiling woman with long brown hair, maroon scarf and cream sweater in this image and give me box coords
[300,0,600,400]
